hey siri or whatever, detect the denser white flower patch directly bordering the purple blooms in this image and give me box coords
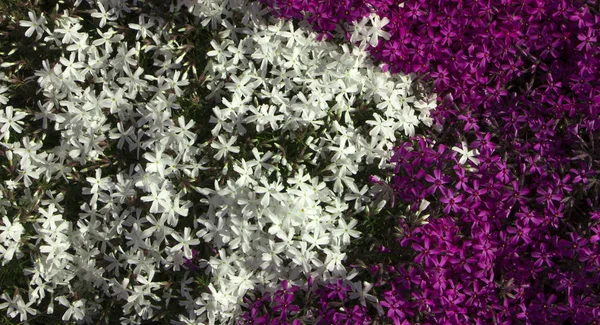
[176,1,433,318]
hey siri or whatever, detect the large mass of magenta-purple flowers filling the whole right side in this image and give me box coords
[262,0,600,324]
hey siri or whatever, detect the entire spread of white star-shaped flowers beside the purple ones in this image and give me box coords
[0,0,435,324]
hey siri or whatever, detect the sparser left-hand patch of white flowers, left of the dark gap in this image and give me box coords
[0,1,199,323]
